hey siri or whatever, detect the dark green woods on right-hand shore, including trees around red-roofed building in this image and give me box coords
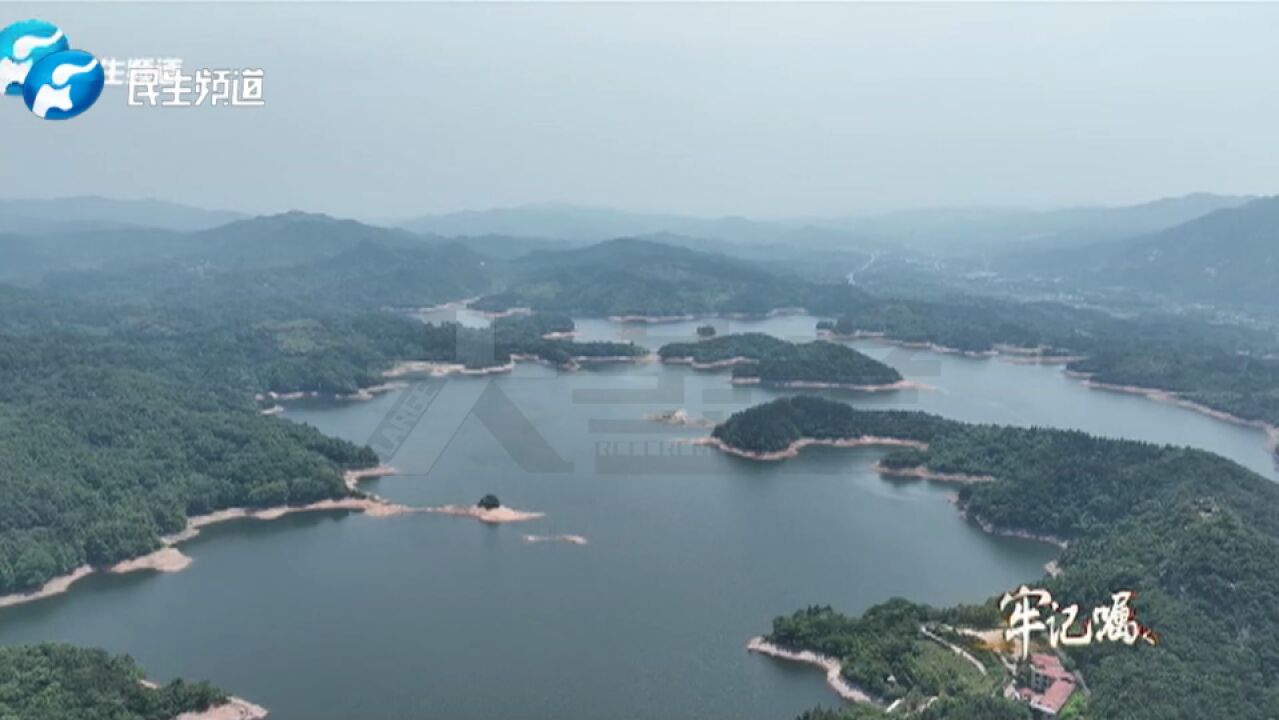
[715,396,1279,720]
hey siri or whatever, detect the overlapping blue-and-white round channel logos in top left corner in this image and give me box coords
[0,20,106,120]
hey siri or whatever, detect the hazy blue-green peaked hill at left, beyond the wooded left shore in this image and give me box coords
[41,214,494,309]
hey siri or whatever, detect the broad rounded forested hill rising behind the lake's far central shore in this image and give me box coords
[475,238,861,317]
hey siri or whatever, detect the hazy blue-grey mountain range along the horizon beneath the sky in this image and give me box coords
[0,194,1279,313]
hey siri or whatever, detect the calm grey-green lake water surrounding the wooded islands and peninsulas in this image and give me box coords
[0,316,1275,720]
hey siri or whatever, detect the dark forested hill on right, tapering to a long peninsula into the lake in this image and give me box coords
[715,398,1279,720]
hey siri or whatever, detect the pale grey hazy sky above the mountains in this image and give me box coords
[7,3,1279,219]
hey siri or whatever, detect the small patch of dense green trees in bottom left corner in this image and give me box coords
[0,645,226,720]
